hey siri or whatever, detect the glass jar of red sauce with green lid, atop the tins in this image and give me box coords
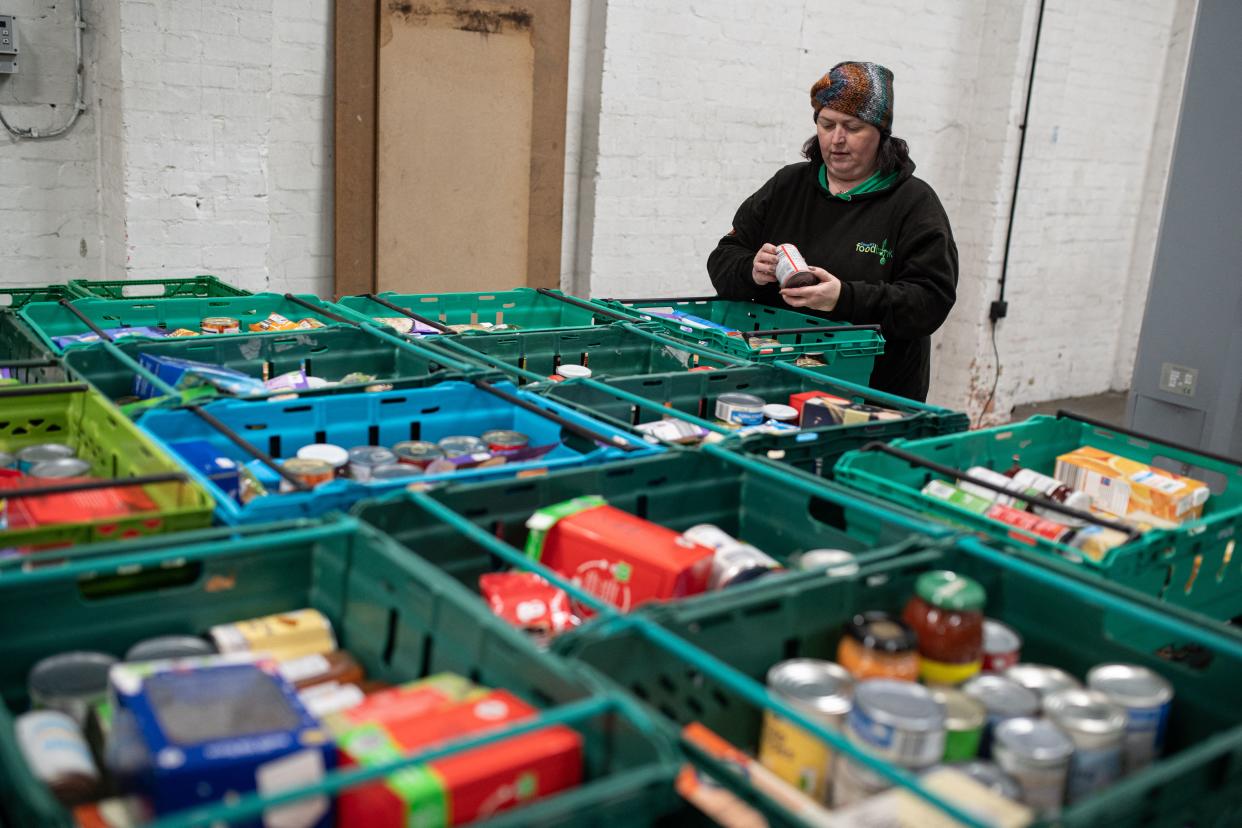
[902,570,987,684]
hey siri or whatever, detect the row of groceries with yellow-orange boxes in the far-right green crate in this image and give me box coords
[923,446,1211,561]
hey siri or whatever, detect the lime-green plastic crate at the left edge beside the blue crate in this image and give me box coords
[0,385,215,547]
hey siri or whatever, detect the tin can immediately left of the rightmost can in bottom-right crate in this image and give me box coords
[1043,690,1125,803]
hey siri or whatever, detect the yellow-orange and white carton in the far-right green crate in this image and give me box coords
[1054,446,1210,523]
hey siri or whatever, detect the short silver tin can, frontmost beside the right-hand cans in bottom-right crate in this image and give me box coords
[995,716,1074,811]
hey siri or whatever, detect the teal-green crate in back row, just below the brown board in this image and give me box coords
[337,288,625,336]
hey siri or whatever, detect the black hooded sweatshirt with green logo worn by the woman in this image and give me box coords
[707,161,958,401]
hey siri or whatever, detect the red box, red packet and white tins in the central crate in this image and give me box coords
[478,495,858,643]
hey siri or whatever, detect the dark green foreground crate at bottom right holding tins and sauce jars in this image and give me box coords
[554,540,1242,827]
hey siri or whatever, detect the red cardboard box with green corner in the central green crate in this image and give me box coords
[525,497,715,614]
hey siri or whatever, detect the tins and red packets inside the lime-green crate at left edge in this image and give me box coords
[0,442,156,530]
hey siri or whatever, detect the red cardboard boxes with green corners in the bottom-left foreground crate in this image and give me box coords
[338,690,582,828]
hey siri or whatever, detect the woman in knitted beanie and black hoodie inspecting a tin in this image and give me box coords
[707,62,958,401]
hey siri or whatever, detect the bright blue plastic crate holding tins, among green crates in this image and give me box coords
[140,381,663,524]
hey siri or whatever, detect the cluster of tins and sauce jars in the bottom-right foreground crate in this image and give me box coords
[759,570,1174,812]
